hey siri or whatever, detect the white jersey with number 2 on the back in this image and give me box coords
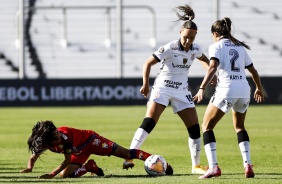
[209,38,252,98]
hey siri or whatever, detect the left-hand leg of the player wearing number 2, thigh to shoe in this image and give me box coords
[200,103,225,179]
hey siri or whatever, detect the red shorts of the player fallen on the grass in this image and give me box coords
[71,133,118,165]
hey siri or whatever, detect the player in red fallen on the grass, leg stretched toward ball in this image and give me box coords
[21,121,173,179]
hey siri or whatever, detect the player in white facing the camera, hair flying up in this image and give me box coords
[123,5,216,174]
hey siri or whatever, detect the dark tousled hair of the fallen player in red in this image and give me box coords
[27,120,57,154]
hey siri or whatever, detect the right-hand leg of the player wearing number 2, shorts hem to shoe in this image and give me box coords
[232,99,255,178]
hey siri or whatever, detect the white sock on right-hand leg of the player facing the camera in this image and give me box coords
[188,137,201,166]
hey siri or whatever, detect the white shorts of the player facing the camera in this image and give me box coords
[149,88,195,113]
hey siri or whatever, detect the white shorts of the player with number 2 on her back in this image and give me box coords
[210,96,250,113]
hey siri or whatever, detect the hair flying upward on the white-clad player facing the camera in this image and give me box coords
[174,5,198,31]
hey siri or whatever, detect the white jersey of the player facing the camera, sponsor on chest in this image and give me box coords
[153,40,203,90]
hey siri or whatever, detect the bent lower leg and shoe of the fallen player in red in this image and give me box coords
[60,154,104,178]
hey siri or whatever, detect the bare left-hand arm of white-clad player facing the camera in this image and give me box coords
[140,56,158,97]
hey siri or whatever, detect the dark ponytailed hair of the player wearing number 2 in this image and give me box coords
[211,17,250,49]
